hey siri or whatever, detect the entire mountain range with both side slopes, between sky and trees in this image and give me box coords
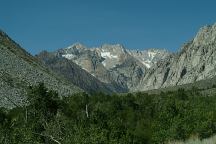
[0,24,216,107]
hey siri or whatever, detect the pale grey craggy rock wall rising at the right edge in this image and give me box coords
[136,24,216,90]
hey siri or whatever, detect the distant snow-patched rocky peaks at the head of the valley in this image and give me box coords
[39,43,169,92]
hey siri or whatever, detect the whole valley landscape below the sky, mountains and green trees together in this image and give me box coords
[0,24,216,144]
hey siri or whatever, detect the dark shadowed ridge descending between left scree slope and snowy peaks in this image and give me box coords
[36,51,122,93]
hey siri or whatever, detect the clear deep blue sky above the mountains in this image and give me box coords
[0,0,216,54]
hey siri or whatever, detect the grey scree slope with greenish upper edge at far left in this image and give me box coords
[0,31,82,108]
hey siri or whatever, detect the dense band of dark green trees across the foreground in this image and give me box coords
[0,84,216,144]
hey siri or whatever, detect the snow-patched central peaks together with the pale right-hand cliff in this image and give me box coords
[37,24,216,90]
